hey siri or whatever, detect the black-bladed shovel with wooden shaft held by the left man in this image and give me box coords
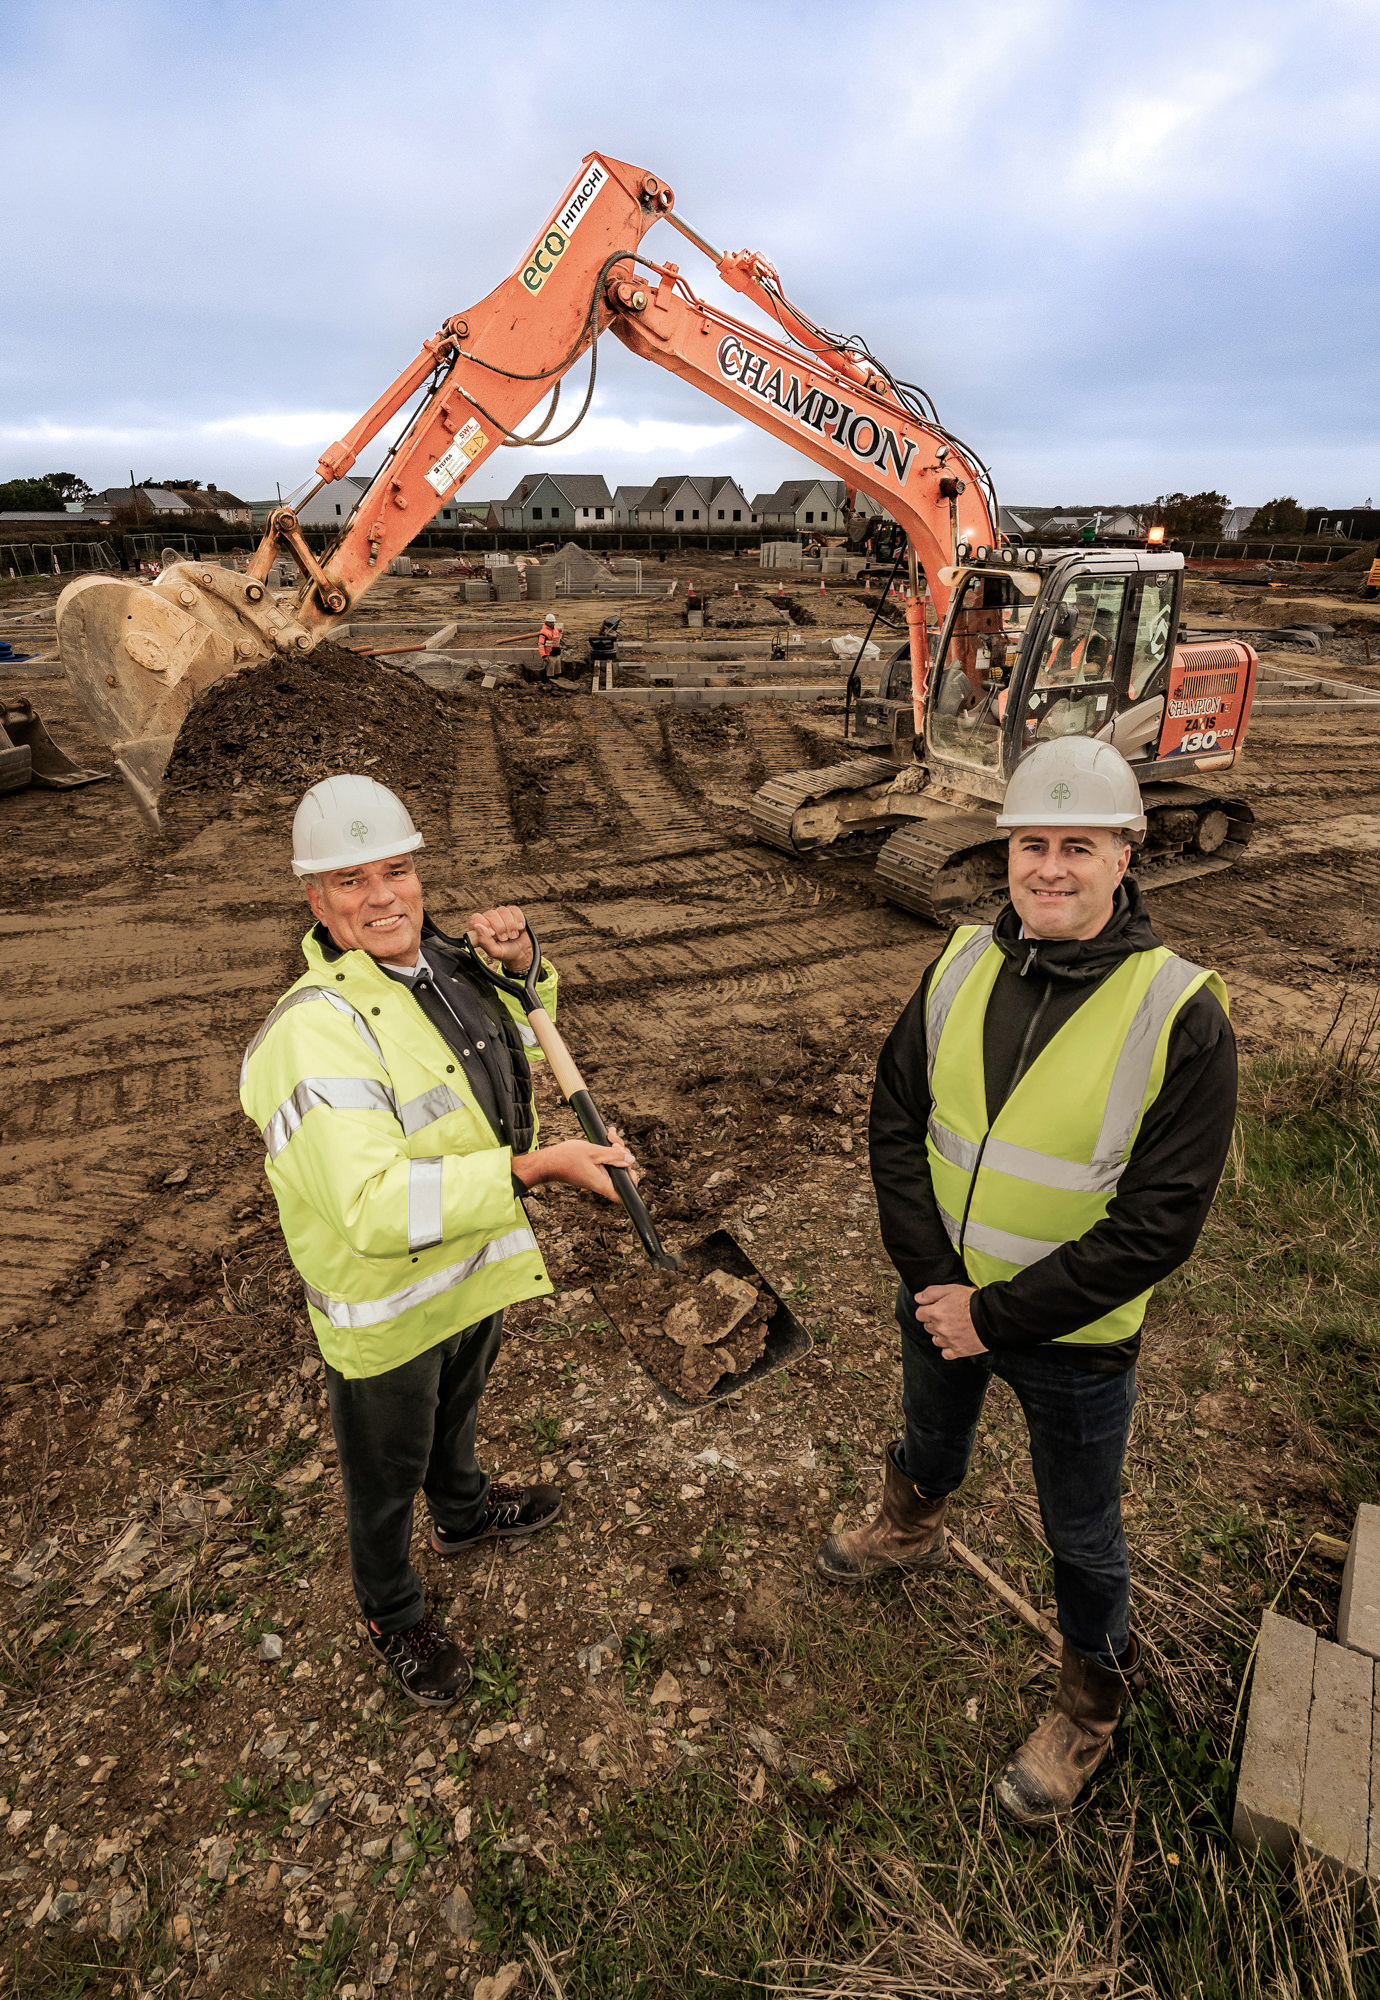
[448,924,814,1408]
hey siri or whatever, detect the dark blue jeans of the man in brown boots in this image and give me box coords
[896,1286,1136,1666]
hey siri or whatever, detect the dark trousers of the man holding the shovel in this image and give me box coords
[326,1312,504,1632]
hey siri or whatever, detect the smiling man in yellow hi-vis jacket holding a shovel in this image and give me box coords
[240,776,632,1708]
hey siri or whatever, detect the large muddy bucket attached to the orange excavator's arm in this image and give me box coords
[58,572,253,828]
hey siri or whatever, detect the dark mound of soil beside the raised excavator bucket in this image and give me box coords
[164,644,472,820]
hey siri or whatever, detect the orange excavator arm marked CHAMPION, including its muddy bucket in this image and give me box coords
[58,154,998,824]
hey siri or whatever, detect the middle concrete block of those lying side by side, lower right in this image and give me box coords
[1298,1638,1376,1880]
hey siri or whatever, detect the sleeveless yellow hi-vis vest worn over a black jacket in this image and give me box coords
[924,924,1228,1346]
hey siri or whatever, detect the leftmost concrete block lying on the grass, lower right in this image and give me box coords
[1232,1612,1318,1854]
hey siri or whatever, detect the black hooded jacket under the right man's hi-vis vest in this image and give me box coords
[870,876,1236,1372]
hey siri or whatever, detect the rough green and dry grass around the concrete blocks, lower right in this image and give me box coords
[498,1050,1380,2000]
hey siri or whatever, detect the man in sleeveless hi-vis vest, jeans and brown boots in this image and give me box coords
[816,736,1236,1822]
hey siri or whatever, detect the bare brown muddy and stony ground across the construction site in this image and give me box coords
[0,556,1380,2000]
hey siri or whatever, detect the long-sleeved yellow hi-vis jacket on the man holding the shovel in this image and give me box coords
[240,932,556,1376]
